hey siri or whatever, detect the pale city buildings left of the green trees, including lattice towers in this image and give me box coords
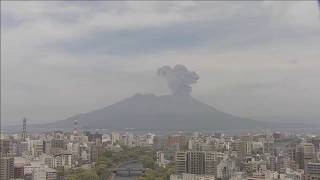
[0,119,155,180]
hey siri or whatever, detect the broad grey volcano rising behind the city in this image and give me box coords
[45,94,269,130]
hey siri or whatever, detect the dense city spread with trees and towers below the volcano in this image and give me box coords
[0,119,320,180]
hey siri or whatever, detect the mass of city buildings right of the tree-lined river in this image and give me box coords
[154,133,320,180]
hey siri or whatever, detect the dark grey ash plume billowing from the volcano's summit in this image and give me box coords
[157,64,199,95]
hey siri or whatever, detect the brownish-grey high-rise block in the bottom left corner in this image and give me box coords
[0,157,14,180]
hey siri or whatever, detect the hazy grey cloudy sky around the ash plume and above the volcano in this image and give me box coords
[1,1,320,125]
